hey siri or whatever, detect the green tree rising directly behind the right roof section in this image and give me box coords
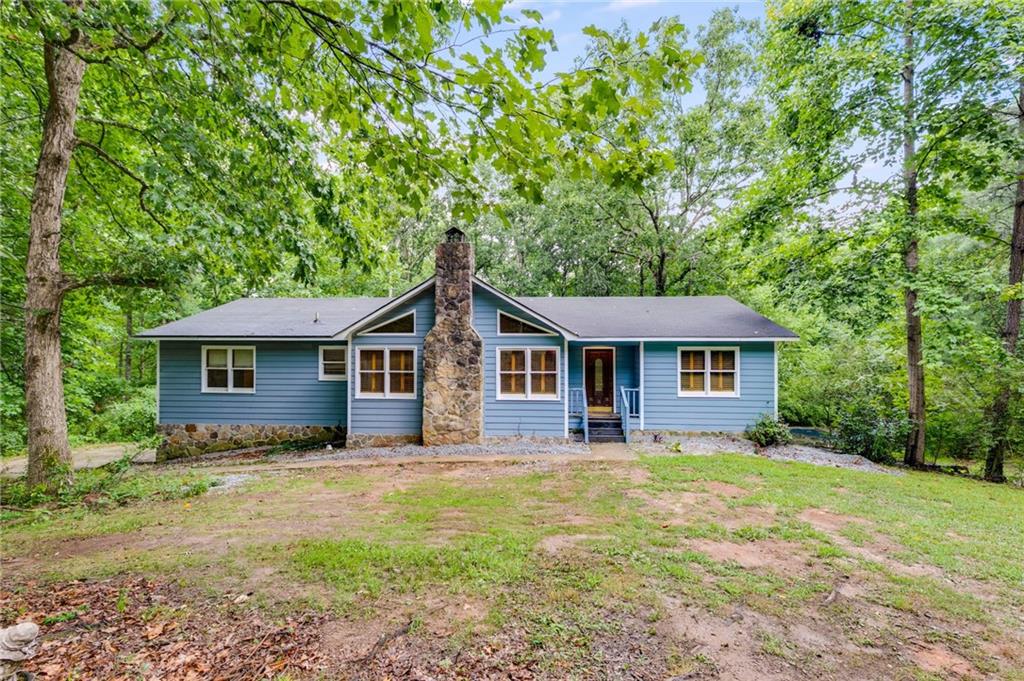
[569,9,768,296]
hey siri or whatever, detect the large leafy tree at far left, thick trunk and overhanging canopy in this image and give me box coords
[0,0,689,488]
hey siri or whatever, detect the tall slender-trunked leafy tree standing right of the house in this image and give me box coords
[765,0,1022,466]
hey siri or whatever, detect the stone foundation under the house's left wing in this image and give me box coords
[157,423,345,461]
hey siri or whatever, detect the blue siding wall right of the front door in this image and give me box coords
[643,342,776,432]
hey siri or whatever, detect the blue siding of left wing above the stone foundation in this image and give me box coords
[158,341,348,426]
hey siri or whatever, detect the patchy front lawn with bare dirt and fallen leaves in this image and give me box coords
[0,455,1024,680]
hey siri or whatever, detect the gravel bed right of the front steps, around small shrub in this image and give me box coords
[637,434,903,475]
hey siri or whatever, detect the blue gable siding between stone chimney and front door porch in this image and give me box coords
[473,286,568,437]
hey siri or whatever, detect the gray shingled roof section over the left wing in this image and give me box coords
[138,298,390,339]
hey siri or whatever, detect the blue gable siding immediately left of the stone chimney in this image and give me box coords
[349,287,434,435]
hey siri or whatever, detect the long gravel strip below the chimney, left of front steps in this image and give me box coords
[265,440,590,462]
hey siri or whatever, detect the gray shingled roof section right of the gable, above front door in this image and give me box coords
[516,296,798,339]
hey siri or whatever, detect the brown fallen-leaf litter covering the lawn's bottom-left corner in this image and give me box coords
[0,578,324,681]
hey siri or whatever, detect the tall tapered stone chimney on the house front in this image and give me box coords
[423,227,483,444]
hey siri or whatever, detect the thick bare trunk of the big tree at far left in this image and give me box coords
[25,31,85,492]
